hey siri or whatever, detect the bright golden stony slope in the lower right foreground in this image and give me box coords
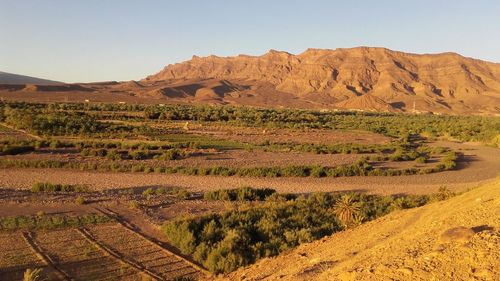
[219,180,500,280]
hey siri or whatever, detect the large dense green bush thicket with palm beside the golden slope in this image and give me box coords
[162,191,450,273]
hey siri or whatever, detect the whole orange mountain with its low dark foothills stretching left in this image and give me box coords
[0,47,500,115]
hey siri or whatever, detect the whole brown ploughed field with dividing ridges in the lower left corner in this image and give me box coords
[0,223,205,280]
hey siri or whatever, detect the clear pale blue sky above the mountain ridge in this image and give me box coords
[0,0,500,82]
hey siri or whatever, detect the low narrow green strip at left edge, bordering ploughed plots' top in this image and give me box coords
[0,214,113,231]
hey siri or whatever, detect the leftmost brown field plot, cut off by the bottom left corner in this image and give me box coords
[0,232,55,280]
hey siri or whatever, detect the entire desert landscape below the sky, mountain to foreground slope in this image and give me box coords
[0,48,500,280]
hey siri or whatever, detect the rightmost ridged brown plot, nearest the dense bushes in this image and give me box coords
[87,224,201,280]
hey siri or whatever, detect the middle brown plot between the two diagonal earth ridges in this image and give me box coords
[33,229,143,280]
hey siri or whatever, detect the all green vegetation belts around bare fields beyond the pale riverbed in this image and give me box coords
[0,102,484,177]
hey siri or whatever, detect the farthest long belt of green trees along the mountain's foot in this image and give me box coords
[0,102,500,142]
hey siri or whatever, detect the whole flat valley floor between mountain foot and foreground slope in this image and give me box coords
[0,103,500,280]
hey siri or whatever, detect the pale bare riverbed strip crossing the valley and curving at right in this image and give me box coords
[0,142,500,194]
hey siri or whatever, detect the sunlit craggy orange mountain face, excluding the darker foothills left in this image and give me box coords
[144,47,500,111]
